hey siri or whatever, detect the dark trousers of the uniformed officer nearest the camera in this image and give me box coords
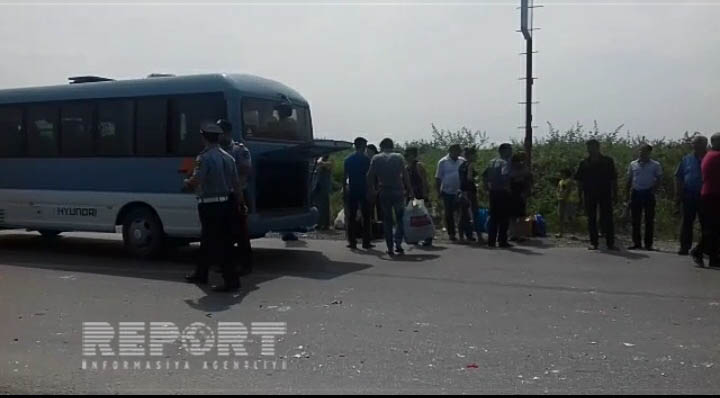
[195,201,240,286]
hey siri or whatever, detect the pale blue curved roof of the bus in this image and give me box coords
[0,73,308,106]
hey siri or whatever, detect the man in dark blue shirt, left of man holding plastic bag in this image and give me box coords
[343,137,373,250]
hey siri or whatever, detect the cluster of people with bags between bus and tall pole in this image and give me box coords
[343,137,531,256]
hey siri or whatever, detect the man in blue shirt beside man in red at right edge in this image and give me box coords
[675,135,708,256]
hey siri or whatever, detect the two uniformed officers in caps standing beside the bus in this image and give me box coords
[185,119,252,292]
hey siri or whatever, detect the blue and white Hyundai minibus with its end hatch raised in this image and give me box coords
[0,74,350,257]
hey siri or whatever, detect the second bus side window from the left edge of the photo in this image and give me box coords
[27,105,59,157]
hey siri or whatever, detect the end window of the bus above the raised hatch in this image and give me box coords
[242,99,312,142]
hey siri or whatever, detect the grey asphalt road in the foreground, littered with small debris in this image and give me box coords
[0,231,720,394]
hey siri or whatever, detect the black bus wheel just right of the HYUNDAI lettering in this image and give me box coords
[123,206,165,259]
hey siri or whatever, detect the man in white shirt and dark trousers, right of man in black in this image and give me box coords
[627,144,662,250]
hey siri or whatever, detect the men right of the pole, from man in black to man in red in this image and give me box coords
[564,133,720,267]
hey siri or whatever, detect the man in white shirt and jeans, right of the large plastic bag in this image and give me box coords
[435,145,465,241]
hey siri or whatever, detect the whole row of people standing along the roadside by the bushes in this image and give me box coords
[344,133,720,267]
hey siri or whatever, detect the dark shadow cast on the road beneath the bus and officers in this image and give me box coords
[0,235,371,312]
